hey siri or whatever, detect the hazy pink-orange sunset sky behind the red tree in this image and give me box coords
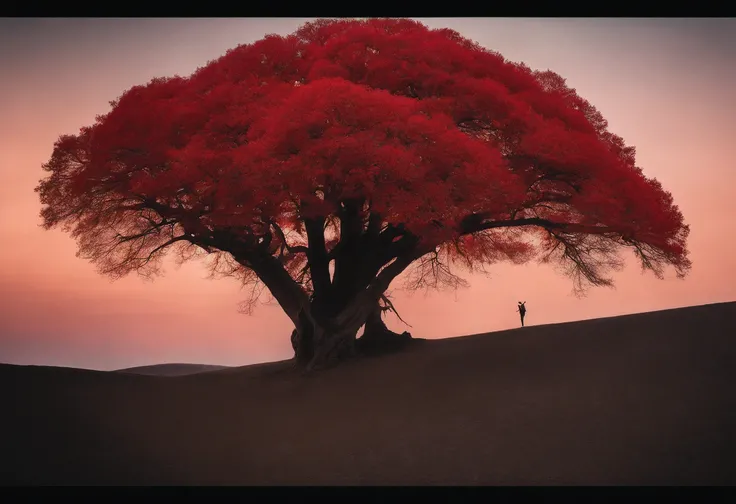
[0,18,736,370]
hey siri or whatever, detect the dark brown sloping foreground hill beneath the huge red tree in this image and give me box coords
[0,303,736,485]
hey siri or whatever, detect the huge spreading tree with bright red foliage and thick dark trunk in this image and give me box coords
[37,19,690,368]
